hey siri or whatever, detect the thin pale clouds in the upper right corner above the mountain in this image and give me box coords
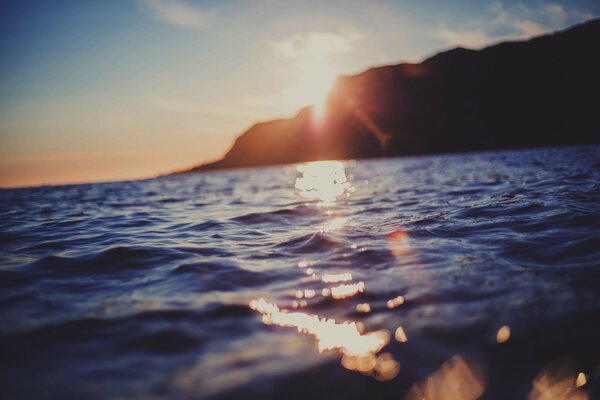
[434,2,593,48]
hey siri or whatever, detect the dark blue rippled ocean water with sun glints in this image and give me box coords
[0,146,600,399]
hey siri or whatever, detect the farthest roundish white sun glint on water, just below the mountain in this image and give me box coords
[295,161,352,205]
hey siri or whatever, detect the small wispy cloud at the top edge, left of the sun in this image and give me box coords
[138,0,213,28]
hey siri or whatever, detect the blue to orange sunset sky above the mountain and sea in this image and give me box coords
[0,0,600,187]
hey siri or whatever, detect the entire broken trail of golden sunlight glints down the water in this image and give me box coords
[249,161,400,381]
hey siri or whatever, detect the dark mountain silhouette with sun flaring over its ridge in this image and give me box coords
[178,19,600,172]
